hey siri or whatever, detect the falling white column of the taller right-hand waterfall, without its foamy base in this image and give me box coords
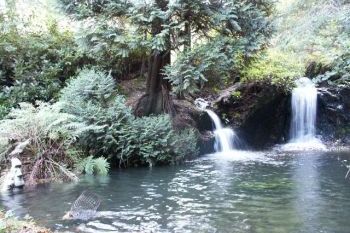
[291,78,317,142]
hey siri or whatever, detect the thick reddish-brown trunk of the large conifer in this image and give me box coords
[135,0,174,116]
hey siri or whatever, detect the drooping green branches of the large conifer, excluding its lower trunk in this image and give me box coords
[61,0,273,95]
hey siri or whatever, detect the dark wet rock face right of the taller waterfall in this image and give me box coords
[317,86,350,143]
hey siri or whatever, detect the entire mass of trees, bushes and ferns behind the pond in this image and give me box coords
[0,0,350,183]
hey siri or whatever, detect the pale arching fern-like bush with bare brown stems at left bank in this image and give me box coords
[0,103,85,184]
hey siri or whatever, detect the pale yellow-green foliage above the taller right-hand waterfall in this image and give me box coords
[245,0,350,85]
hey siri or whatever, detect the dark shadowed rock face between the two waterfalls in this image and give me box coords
[215,82,291,149]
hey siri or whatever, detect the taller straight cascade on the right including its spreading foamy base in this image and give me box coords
[283,78,326,150]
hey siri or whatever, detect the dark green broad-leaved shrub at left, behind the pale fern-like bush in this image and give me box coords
[0,17,83,111]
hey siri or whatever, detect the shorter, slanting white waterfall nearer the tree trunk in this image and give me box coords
[205,109,237,152]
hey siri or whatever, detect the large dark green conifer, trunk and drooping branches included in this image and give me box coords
[61,0,273,115]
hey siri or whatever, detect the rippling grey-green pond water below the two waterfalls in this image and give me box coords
[0,152,350,233]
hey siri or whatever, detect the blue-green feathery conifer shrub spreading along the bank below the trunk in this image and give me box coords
[60,70,197,167]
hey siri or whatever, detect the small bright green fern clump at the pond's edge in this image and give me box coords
[77,156,110,176]
